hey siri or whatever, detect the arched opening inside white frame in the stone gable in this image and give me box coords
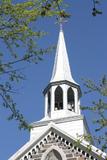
[45,149,62,160]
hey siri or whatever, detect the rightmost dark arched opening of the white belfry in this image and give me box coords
[67,87,75,111]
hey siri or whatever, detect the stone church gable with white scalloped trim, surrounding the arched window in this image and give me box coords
[9,122,107,160]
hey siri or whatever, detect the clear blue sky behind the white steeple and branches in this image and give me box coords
[0,0,107,160]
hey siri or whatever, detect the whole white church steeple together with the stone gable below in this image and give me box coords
[9,21,107,160]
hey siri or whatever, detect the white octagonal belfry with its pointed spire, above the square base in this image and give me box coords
[44,24,81,119]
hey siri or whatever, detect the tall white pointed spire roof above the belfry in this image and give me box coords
[50,24,77,84]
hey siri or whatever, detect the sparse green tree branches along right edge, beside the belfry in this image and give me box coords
[81,75,107,151]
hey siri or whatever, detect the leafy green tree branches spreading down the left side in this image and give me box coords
[0,0,69,129]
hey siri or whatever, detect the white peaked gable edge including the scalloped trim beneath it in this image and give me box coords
[8,122,107,160]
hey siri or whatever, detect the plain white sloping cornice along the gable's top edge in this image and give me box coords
[8,122,107,160]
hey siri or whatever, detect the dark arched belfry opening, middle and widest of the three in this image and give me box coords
[55,86,63,110]
